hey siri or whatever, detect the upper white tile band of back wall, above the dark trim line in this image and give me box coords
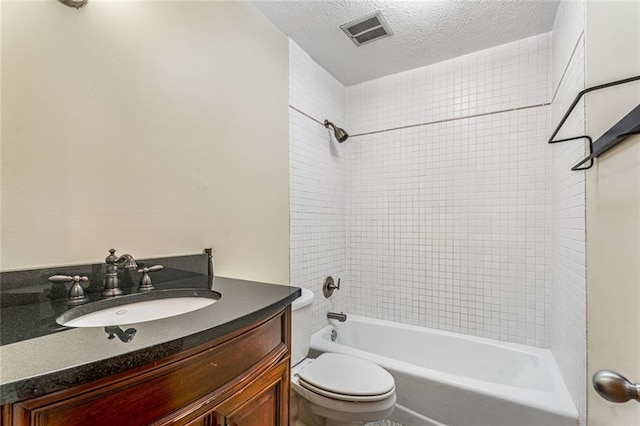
[347,34,550,135]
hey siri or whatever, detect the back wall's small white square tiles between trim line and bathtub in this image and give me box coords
[348,107,550,346]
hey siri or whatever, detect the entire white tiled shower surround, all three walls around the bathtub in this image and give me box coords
[290,17,585,423]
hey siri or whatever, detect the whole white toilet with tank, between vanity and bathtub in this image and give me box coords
[291,288,396,426]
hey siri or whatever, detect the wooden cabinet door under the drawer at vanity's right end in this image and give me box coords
[213,358,289,426]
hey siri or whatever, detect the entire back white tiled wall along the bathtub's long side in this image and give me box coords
[347,34,551,347]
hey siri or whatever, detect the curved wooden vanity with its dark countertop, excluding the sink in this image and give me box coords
[0,253,300,426]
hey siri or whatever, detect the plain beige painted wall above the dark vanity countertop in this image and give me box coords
[0,0,289,284]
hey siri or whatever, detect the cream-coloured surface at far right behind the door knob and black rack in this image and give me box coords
[585,1,640,426]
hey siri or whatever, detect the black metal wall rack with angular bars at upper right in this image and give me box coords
[548,75,640,171]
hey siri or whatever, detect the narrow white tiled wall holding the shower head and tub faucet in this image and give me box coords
[289,41,349,331]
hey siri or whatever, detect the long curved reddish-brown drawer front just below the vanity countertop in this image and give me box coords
[5,309,290,426]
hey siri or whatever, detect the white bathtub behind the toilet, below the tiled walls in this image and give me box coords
[311,315,578,426]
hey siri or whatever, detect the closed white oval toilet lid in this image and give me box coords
[298,353,395,401]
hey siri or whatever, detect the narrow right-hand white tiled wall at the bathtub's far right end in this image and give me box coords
[551,1,587,425]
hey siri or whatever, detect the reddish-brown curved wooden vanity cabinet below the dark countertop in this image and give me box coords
[2,307,291,426]
